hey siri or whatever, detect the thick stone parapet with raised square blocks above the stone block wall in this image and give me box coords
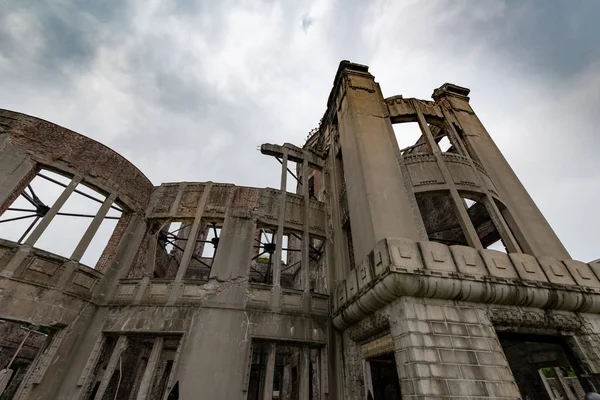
[331,238,600,329]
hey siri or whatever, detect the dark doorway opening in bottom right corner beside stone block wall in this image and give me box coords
[498,332,592,400]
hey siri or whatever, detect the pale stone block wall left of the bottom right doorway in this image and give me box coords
[388,297,520,400]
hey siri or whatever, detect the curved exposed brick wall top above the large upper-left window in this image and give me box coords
[0,110,154,211]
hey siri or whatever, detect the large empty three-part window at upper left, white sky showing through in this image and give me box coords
[0,170,123,267]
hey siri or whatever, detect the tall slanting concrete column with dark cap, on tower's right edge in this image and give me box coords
[433,83,570,260]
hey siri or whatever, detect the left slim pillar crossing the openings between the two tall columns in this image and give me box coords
[411,99,483,249]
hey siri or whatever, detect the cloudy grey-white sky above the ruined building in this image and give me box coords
[0,0,600,261]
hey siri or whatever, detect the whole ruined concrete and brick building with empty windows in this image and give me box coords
[0,62,600,400]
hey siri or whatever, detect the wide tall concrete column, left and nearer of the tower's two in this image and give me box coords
[328,63,419,262]
